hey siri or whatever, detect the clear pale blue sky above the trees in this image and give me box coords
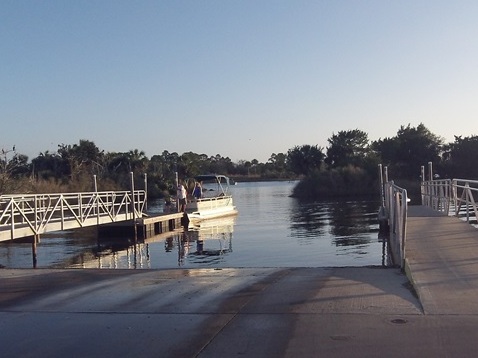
[0,0,478,162]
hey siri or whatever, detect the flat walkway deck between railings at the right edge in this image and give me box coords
[405,206,478,315]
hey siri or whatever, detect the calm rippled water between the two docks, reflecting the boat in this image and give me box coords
[0,182,387,269]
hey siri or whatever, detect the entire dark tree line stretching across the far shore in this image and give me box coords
[0,124,478,198]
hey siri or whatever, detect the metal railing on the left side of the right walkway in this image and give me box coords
[384,181,408,268]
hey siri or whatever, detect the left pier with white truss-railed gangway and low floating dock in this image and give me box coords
[0,190,184,267]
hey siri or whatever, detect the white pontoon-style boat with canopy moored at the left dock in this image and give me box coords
[186,174,237,222]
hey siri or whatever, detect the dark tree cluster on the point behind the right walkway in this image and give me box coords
[294,123,478,200]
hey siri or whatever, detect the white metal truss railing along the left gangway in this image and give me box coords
[0,190,146,241]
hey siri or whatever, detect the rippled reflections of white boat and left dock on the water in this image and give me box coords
[70,215,236,269]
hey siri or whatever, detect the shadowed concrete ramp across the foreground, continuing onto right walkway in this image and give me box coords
[0,206,478,358]
